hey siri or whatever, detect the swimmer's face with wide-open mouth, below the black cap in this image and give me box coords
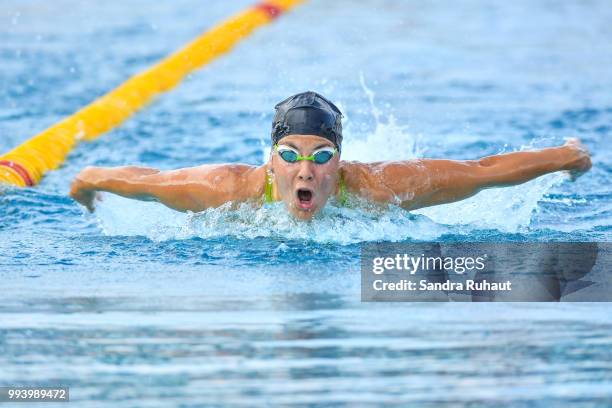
[270,135,340,220]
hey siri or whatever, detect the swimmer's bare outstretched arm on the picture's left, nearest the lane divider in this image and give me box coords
[70,164,265,212]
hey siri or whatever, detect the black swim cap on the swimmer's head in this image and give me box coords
[272,91,342,151]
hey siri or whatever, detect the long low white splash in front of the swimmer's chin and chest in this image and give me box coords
[96,194,449,245]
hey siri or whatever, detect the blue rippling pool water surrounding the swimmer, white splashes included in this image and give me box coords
[0,0,612,407]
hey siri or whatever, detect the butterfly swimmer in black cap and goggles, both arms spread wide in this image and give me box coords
[70,92,591,220]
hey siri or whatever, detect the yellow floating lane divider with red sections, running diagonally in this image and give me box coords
[0,0,304,187]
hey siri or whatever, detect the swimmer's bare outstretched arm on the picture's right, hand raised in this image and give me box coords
[345,139,591,210]
